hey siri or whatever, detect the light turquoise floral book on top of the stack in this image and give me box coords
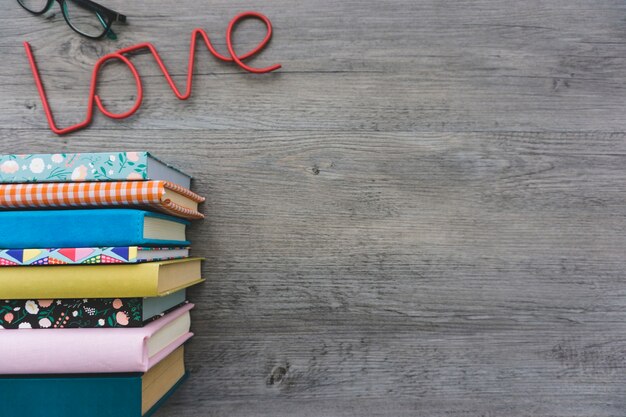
[0,152,191,188]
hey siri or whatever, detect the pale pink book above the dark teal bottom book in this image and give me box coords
[0,304,194,375]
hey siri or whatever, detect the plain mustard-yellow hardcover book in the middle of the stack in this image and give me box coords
[0,258,203,300]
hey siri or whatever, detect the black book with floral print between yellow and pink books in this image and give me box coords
[0,289,186,330]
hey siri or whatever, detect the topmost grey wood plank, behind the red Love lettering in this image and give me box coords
[0,0,626,131]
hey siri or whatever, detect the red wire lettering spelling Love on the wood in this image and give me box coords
[24,12,281,135]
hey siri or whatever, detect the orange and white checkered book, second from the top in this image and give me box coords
[0,181,204,219]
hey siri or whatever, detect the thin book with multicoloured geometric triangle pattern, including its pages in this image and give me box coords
[0,246,189,267]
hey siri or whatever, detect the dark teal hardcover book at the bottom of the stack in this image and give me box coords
[0,346,186,417]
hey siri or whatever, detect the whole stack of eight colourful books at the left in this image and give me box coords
[0,152,204,417]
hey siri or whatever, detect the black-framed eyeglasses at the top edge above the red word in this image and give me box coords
[17,0,126,39]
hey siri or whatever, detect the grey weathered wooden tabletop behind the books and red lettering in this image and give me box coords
[0,0,626,417]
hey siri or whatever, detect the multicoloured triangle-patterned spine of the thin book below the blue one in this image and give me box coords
[0,246,137,266]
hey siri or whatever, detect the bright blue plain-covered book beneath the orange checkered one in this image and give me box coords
[0,209,189,249]
